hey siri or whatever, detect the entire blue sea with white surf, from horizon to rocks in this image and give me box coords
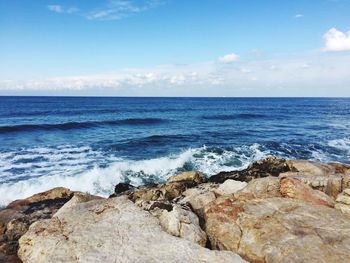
[0,97,350,205]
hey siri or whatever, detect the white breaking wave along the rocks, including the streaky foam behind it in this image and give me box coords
[0,144,269,205]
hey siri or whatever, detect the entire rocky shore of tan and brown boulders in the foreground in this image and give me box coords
[0,157,350,263]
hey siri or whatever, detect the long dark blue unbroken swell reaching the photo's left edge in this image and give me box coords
[0,118,168,133]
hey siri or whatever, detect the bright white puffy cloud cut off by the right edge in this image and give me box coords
[323,27,350,51]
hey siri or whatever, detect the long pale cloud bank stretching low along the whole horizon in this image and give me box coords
[0,54,350,96]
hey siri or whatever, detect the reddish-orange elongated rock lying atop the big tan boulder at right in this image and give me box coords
[280,177,334,207]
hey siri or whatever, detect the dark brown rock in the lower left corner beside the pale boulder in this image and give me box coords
[0,187,74,262]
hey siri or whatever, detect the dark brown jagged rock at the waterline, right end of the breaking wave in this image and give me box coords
[209,156,290,183]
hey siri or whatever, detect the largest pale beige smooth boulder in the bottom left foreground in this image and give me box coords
[18,196,245,263]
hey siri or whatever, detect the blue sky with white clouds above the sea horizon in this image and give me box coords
[0,0,350,97]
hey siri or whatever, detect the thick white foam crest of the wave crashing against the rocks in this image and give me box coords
[0,144,269,205]
